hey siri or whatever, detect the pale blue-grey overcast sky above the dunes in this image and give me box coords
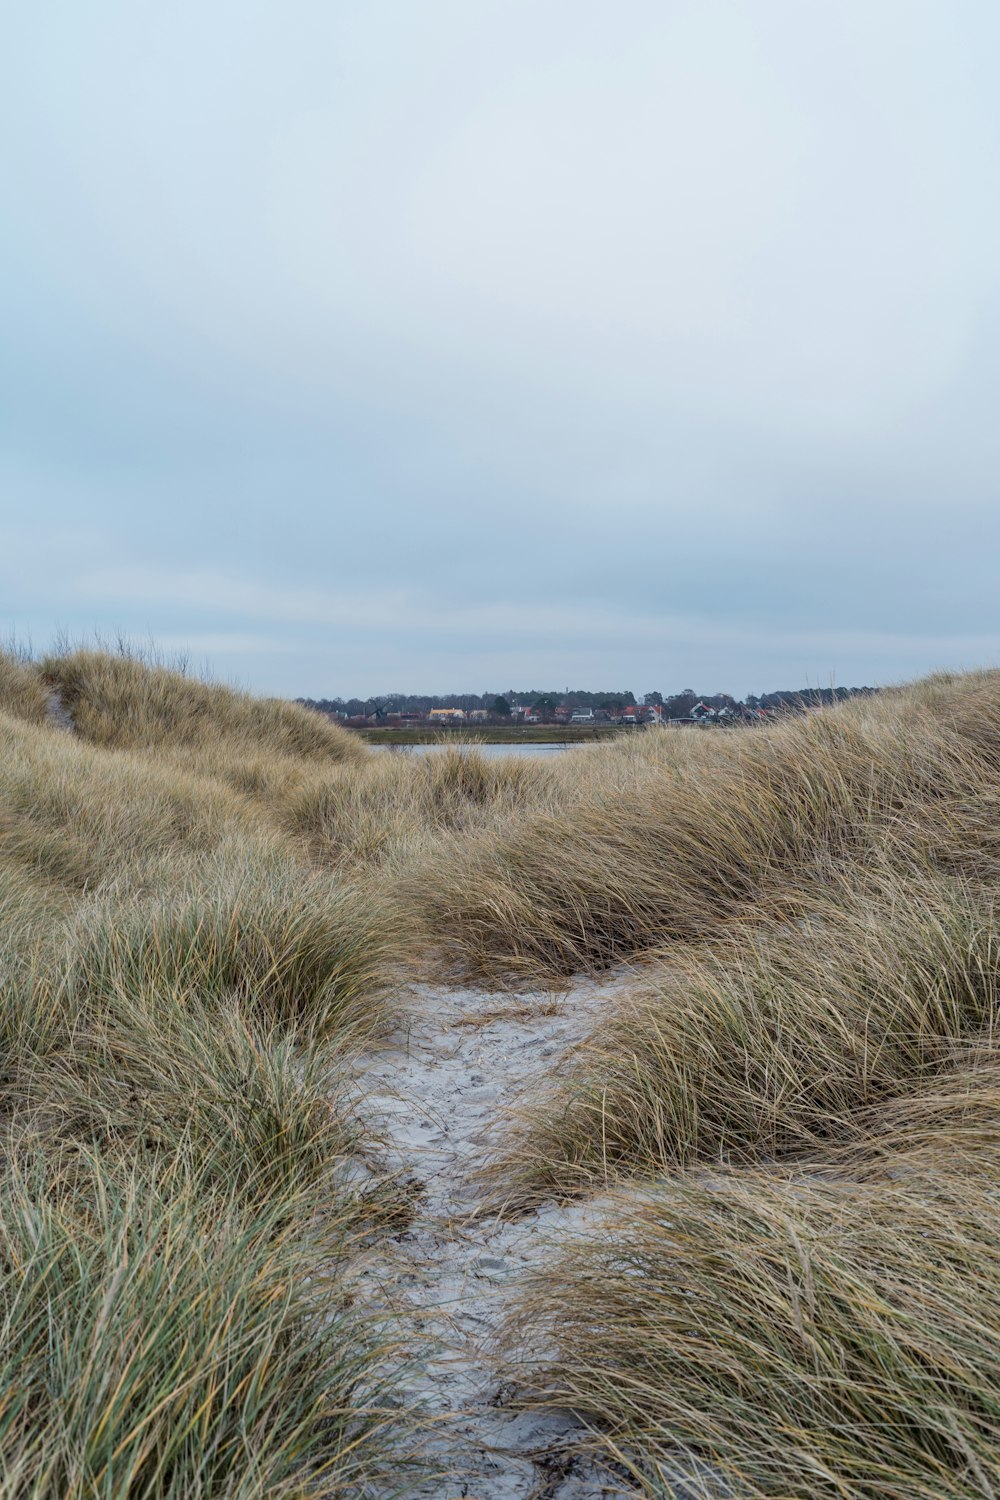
[0,0,1000,696]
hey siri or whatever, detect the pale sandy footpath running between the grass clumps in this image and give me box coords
[353,986,627,1500]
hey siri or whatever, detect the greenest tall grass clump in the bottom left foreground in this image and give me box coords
[0,1149,401,1500]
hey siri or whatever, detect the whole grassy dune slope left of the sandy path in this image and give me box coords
[0,654,410,1500]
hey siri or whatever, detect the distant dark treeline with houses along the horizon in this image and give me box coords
[298,687,879,719]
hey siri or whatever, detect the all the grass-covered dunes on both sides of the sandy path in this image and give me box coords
[0,653,1000,1500]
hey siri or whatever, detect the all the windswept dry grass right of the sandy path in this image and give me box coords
[461,674,1000,1500]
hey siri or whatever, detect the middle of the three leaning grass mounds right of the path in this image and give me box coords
[505,873,1000,1197]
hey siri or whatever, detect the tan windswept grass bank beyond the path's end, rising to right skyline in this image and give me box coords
[402,674,1000,983]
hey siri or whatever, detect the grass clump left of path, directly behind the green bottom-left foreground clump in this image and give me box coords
[17,989,366,1200]
